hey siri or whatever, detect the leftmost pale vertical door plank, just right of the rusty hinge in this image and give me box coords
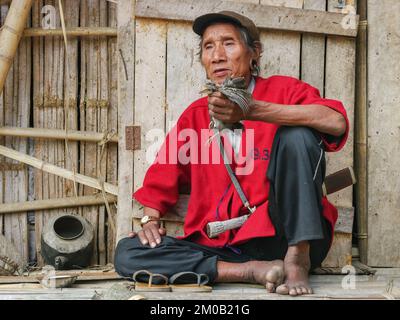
[134,19,169,229]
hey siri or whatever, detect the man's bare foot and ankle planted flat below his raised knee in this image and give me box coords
[276,241,313,296]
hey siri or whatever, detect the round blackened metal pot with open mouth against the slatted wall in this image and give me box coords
[41,215,94,270]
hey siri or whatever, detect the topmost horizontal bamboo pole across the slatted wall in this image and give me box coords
[23,27,117,37]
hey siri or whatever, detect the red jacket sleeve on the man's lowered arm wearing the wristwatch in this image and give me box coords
[133,117,190,216]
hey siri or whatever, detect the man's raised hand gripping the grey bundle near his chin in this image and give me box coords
[208,92,246,123]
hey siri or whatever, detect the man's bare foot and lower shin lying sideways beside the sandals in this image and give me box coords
[215,260,285,293]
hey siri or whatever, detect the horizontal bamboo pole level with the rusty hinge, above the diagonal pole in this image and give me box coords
[0,127,118,143]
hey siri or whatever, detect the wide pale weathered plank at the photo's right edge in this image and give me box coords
[367,0,400,267]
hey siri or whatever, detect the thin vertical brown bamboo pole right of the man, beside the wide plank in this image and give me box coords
[354,0,368,264]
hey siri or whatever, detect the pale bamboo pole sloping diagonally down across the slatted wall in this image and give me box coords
[0,146,118,195]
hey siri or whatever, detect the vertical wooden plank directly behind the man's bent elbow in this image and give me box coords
[323,0,356,267]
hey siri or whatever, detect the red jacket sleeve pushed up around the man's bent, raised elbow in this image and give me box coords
[289,79,350,151]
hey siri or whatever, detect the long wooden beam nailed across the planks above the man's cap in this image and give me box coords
[135,0,359,38]
